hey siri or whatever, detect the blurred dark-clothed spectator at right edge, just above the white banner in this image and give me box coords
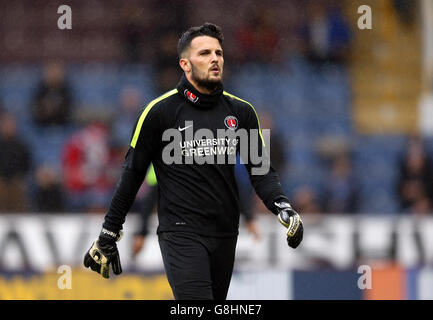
[397,136,433,213]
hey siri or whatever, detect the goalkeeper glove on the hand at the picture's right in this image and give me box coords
[275,201,304,248]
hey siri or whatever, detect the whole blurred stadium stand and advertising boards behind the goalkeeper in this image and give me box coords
[0,0,433,299]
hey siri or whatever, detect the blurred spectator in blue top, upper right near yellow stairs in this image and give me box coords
[301,1,351,65]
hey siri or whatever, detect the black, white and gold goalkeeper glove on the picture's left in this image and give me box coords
[84,228,123,279]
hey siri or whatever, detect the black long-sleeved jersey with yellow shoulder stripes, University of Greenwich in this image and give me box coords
[103,75,287,237]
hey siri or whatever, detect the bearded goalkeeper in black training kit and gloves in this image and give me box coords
[84,23,303,300]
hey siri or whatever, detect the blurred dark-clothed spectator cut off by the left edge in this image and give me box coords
[0,113,31,212]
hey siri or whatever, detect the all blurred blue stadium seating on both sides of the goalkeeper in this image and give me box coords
[0,57,418,213]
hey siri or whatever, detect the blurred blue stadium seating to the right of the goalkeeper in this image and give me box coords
[226,58,412,214]
